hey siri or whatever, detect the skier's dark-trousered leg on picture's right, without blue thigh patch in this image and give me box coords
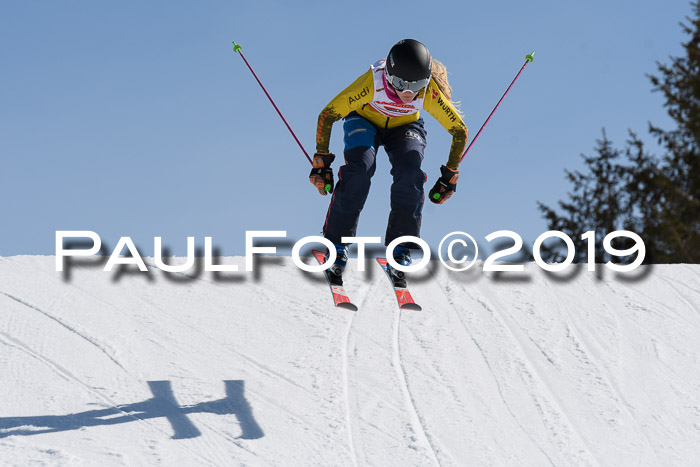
[384,119,427,248]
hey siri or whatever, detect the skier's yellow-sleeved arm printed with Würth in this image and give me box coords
[423,80,469,170]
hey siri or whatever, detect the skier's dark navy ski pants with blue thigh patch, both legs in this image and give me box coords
[323,112,427,248]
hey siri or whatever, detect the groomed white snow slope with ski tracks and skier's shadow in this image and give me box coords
[0,256,700,466]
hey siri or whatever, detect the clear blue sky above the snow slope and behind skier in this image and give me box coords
[0,0,691,256]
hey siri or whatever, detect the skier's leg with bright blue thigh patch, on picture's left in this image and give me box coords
[323,114,377,244]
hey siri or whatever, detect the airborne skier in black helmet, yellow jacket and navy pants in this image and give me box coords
[309,39,468,283]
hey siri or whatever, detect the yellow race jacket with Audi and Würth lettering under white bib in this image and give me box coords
[316,68,469,169]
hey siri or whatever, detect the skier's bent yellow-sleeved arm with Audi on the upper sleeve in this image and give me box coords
[316,70,374,154]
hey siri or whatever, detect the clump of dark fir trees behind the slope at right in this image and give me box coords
[538,2,700,263]
